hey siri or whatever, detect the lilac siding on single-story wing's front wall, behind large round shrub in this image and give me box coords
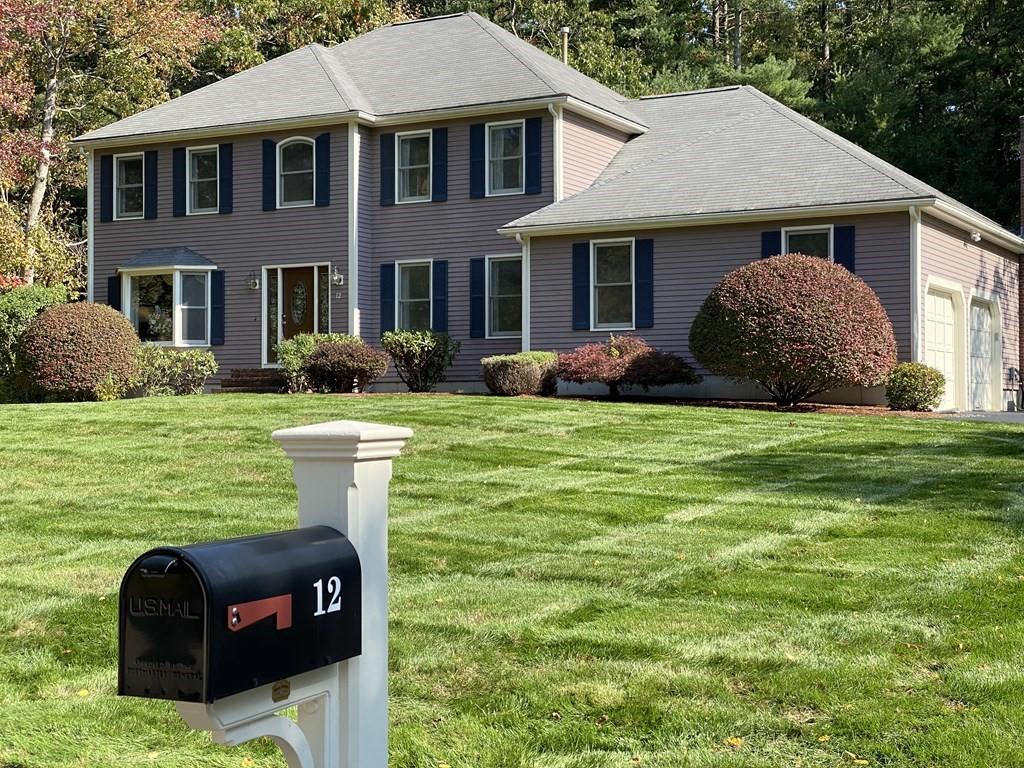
[530,213,910,370]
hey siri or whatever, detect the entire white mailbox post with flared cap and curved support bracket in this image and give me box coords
[177,421,413,768]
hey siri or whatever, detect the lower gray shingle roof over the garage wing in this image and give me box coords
[506,86,995,234]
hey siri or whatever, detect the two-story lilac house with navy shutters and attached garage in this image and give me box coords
[76,13,1024,410]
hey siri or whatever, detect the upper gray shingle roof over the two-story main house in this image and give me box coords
[76,13,640,141]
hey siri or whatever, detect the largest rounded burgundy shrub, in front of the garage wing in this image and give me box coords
[690,254,896,408]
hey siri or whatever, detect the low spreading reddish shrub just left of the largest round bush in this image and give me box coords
[558,336,700,397]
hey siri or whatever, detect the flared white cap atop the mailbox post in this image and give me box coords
[270,421,413,461]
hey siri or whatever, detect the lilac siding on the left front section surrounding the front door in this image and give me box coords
[94,126,348,374]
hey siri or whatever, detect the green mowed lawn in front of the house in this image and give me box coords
[0,395,1024,768]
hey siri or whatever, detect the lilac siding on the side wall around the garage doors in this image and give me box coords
[921,214,1021,386]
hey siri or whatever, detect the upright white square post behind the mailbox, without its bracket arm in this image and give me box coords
[272,421,413,768]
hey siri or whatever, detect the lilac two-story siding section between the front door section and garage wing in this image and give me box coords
[359,112,553,383]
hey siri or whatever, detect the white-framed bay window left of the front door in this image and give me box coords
[123,269,210,346]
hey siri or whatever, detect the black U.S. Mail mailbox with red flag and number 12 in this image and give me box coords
[118,525,362,702]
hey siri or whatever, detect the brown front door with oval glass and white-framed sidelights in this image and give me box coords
[263,264,331,366]
